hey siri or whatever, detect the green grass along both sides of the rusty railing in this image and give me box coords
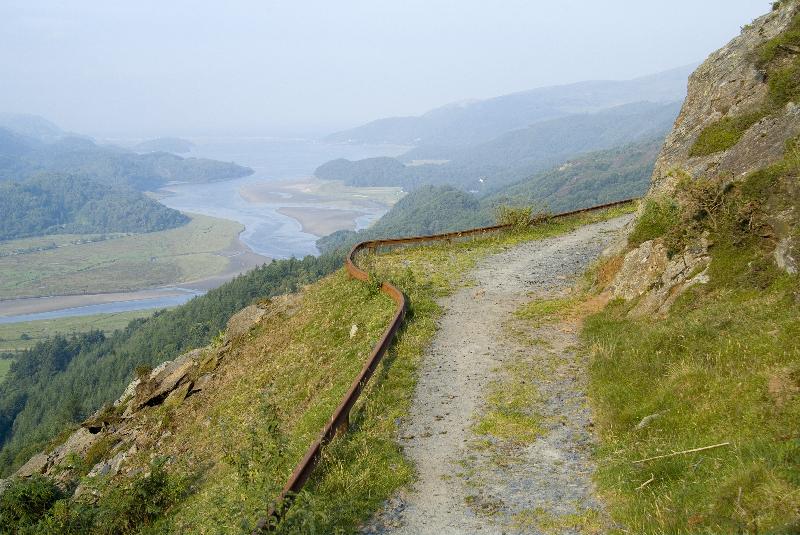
[159,207,631,533]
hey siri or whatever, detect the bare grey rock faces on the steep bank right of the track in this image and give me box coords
[609,0,800,310]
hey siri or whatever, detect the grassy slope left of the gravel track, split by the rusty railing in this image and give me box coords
[111,204,632,533]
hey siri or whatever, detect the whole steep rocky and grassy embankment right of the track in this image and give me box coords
[584,1,800,533]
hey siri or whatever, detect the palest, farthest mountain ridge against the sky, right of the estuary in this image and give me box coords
[326,65,695,146]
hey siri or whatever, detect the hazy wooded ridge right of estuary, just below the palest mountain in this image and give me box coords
[315,102,680,193]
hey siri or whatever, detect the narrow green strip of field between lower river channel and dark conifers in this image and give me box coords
[0,310,153,356]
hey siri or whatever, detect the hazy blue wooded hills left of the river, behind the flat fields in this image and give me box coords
[0,123,252,240]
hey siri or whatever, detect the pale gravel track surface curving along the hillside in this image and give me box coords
[362,216,630,535]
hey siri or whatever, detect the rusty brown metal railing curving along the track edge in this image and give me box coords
[253,198,638,534]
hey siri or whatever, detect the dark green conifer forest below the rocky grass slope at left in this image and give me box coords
[0,252,343,476]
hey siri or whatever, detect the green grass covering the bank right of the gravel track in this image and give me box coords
[583,153,800,534]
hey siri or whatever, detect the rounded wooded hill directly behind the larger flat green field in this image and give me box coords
[0,173,189,240]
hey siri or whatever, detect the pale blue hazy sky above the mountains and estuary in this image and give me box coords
[0,0,770,136]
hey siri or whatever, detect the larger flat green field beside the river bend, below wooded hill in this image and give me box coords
[0,215,243,299]
